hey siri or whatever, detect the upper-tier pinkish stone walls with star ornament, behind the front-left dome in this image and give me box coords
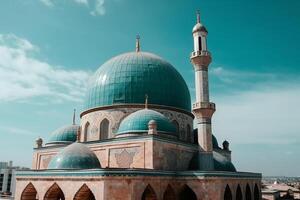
[32,135,198,170]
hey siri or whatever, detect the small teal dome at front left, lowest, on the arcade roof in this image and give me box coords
[48,143,101,169]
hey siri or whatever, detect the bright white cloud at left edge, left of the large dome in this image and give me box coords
[0,34,89,102]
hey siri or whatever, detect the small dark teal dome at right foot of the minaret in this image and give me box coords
[213,151,236,172]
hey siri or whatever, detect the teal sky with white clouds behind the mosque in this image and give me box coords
[0,0,300,176]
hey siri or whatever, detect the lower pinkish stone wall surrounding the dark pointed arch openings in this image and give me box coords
[16,174,261,200]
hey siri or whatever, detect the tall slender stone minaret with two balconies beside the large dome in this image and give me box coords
[191,12,215,170]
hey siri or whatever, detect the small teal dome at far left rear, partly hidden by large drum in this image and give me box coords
[46,125,80,145]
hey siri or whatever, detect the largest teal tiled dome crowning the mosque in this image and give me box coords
[85,52,191,111]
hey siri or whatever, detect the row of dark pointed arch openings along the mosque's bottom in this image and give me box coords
[21,183,260,200]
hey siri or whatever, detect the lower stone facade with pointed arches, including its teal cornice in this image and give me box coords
[16,170,261,200]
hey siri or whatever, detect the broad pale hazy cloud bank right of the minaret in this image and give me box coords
[213,83,300,144]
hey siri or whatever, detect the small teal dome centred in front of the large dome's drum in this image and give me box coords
[117,109,176,136]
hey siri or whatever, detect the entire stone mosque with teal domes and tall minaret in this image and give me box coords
[15,14,261,200]
